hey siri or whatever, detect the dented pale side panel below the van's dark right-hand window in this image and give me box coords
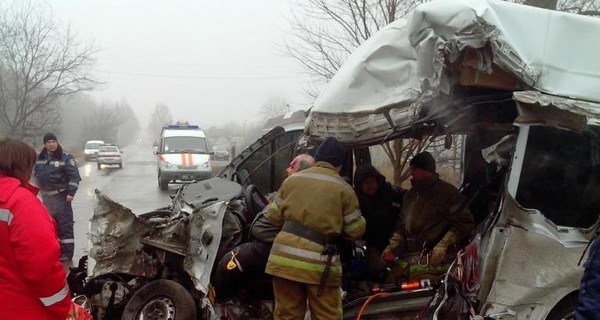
[481,194,590,319]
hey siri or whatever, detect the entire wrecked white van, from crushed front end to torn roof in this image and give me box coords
[69,0,600,320]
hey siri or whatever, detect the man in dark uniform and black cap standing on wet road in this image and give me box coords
[34,132,81,267]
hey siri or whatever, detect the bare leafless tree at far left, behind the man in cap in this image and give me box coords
[0,0,98,138]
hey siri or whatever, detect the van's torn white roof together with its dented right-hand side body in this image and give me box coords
[306,0,600,319]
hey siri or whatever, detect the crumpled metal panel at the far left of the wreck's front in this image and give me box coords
[89,189,157,277]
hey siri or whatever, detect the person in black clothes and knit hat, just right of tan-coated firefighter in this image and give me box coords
[354,164,405,282]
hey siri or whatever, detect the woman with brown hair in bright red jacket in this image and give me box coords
[0,139,72,320]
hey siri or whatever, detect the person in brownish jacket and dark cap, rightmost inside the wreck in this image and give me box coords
[382,151,475,281]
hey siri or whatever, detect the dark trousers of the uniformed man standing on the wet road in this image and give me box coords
[42,191,75,261]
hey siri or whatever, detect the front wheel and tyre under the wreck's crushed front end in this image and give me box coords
[121,279,196,320]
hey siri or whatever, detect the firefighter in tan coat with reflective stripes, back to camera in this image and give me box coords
[265,138,365,320]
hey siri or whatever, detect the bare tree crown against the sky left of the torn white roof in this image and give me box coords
[284,0,424,97]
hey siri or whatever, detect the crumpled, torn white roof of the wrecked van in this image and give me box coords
[306,0,600,143]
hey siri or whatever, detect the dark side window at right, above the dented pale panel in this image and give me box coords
[516,126,600,228]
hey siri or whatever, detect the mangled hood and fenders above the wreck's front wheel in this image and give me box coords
[88,178,241,293]
